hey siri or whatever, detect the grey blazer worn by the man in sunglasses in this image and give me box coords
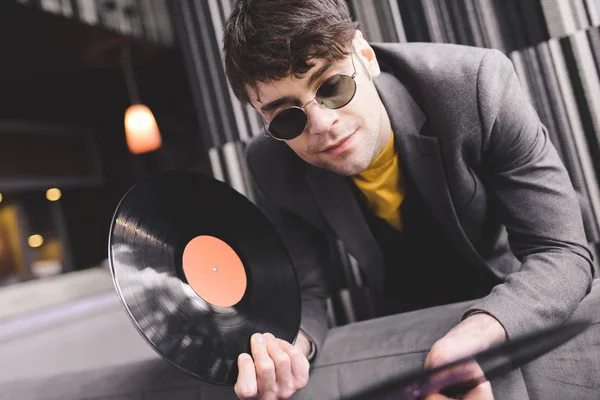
[247,43,594,360]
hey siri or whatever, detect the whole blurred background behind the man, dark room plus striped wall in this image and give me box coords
[0,0,600,325]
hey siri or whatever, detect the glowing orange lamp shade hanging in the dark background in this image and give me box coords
[125,104,162,154]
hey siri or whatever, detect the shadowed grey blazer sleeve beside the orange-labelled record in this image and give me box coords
[247,148,328,362]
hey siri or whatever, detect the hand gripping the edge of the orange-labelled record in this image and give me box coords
[234,332,310,400]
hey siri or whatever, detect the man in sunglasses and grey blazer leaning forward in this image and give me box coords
[224,0,597,399]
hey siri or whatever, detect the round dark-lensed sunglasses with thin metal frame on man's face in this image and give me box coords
[265,56,356,140]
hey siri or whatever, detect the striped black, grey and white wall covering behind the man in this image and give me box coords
[23,0,600,324]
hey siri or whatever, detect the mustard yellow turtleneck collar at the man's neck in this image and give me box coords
[352,132,406,231]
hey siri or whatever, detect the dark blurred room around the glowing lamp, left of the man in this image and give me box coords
[0,0,210,284]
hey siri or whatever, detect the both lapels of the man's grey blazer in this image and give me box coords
[306,73,484,291]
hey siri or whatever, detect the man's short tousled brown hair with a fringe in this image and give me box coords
[223,0,358,103]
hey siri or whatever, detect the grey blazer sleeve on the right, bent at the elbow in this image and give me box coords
[463,50,594,337]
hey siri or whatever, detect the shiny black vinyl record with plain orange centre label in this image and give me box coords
[109,171,301,385]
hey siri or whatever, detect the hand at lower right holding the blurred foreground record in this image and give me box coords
[425,313,506,400]
